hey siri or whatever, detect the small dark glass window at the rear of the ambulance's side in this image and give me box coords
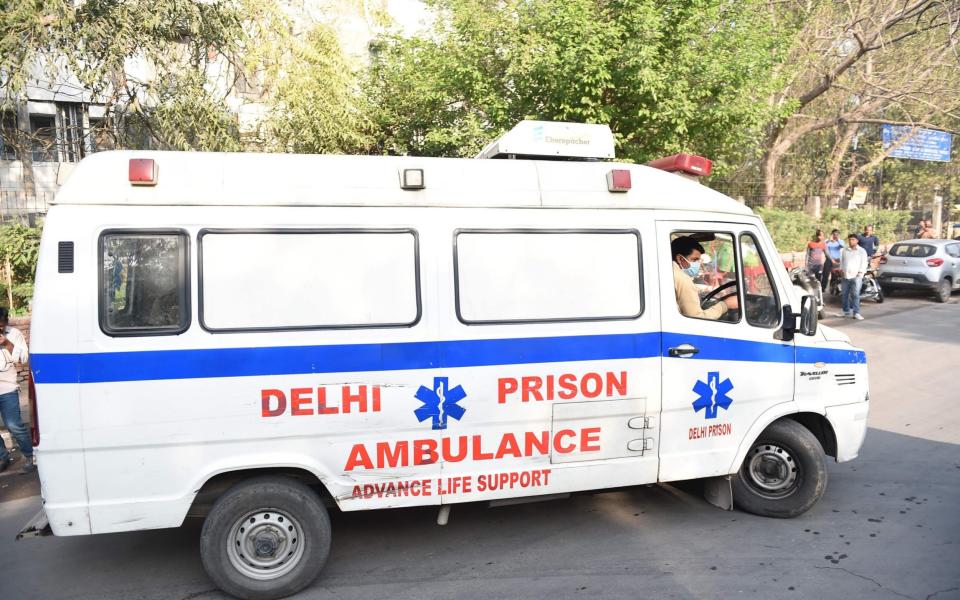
[99,231,190,336]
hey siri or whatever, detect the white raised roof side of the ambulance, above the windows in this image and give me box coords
[54,151,752,215]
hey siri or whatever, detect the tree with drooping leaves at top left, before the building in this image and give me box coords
[0,0,251,150]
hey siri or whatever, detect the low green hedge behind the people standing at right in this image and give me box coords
[754,208,912,252]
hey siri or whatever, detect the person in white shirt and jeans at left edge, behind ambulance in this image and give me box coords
[0,307,36,473]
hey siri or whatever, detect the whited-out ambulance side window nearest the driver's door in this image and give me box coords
[454,230,643,324]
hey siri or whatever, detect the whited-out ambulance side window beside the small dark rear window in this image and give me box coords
[199,229,420,332]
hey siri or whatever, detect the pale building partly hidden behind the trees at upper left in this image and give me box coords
[0,0,429,224]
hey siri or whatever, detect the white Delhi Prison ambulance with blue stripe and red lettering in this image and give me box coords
[21,121,869,599]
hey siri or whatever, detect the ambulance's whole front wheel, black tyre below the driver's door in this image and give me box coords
[733,419,827,519]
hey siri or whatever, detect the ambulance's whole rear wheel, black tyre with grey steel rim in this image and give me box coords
[200,475,330,600]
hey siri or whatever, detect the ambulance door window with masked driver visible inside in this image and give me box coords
[670,231,740,323]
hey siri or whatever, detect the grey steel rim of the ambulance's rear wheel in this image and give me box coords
[227,508,304,581]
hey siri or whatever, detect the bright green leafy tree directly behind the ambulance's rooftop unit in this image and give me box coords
[366,0,782,173]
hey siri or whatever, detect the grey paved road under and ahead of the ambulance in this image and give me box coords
[0,295,960,600]
